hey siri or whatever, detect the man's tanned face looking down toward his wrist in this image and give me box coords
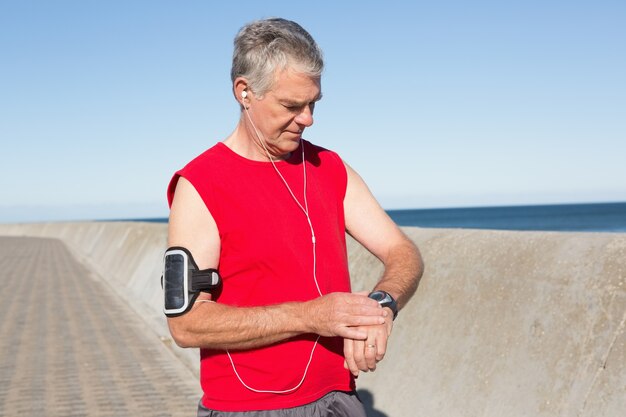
[249,69,321,158]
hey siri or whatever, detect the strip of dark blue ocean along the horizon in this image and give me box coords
[132,203,626,233]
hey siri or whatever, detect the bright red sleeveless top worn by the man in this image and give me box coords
[168,142,354,411]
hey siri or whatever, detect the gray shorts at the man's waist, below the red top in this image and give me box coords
[198,391,366,417]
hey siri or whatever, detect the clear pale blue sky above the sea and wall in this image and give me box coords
[0,0,626,222]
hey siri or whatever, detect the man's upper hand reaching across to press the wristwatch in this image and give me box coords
[305,293,386,340]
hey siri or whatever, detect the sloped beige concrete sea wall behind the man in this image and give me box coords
[0,223,626,417]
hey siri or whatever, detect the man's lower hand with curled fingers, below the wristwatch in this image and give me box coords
[343,308,393,376]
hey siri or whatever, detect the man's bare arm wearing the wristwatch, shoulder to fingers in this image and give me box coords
[344,160,424,376]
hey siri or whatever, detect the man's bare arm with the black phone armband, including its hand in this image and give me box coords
[167,177,392,350]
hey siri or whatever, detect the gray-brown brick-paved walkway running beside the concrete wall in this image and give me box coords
[0,237,200,417]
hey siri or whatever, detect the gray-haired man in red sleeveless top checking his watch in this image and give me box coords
[168,19,423,416]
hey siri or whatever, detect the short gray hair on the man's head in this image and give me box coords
[230,18,324,96]
